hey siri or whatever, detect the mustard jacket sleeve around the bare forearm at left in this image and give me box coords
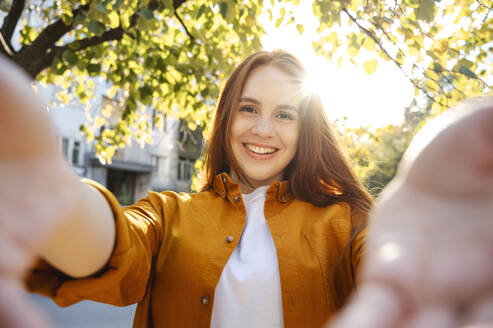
[25,179,164,306]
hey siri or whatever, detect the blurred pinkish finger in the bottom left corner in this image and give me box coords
[0,278,54,328]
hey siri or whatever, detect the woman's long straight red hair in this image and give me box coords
[201,50,372,213]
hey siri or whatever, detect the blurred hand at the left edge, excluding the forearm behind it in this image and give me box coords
[0,58,79,327]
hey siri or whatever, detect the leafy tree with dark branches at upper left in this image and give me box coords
[0,0,262,158]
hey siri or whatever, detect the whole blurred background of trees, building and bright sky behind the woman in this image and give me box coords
[0,0,493,327]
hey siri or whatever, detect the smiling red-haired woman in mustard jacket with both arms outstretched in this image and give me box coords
[0,52,493,328]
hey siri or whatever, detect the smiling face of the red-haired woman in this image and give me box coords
[230,66,300,192]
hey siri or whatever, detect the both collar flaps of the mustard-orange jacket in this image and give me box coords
[212,172,294,203]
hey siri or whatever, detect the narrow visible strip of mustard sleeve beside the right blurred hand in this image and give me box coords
[351,213,368,286]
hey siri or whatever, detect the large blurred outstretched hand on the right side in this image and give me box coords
[331,98,493,328]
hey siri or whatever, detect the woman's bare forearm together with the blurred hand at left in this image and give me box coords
[0,58,114,327]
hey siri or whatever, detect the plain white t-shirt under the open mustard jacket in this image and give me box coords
[211,186,283,328]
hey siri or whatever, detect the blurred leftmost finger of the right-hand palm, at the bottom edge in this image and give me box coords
[330,283,404,328]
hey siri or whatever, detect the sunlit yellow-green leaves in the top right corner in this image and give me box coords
[313,0,493,112]
